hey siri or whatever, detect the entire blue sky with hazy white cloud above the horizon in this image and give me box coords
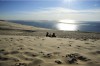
[0,0,100,21]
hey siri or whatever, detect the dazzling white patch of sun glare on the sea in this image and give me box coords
[56,19,78,31]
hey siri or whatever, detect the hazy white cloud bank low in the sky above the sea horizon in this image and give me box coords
[0,7,100,21]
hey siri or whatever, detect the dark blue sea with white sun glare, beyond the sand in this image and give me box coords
[9,20,100,32]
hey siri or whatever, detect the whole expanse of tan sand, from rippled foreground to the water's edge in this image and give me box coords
[0,21,100,66]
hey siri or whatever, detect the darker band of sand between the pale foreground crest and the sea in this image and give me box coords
[0,21,100,39]
